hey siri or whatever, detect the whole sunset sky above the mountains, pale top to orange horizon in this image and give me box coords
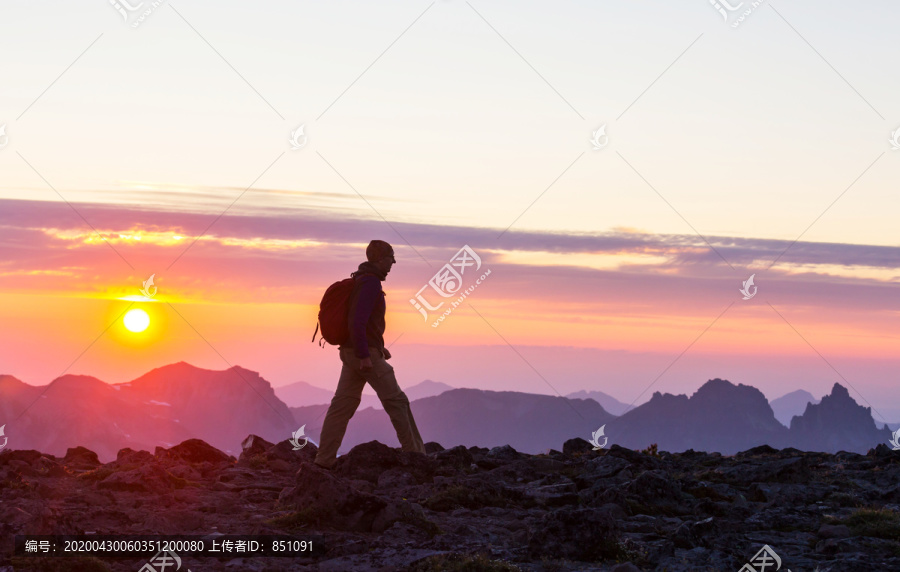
[0,0,900,422]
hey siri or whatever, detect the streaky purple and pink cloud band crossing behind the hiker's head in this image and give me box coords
[0,200,900,309]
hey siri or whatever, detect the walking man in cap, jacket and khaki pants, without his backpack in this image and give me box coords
[315,240,425,469]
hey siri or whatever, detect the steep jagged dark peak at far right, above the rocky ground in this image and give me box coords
[790,383,891,453]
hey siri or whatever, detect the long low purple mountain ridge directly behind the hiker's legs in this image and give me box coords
[291,388,614,454]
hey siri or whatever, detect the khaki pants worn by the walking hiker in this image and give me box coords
[316,347,425,467]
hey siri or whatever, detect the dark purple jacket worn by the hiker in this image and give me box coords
[340,262,387,359]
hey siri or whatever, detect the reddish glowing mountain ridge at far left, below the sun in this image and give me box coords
[0,362,297,459]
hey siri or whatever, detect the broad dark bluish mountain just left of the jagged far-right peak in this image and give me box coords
[606,378,787,455]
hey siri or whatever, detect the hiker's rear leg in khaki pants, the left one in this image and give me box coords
[315,348,366,467]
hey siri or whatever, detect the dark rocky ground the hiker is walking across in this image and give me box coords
[0,436,900,572]
